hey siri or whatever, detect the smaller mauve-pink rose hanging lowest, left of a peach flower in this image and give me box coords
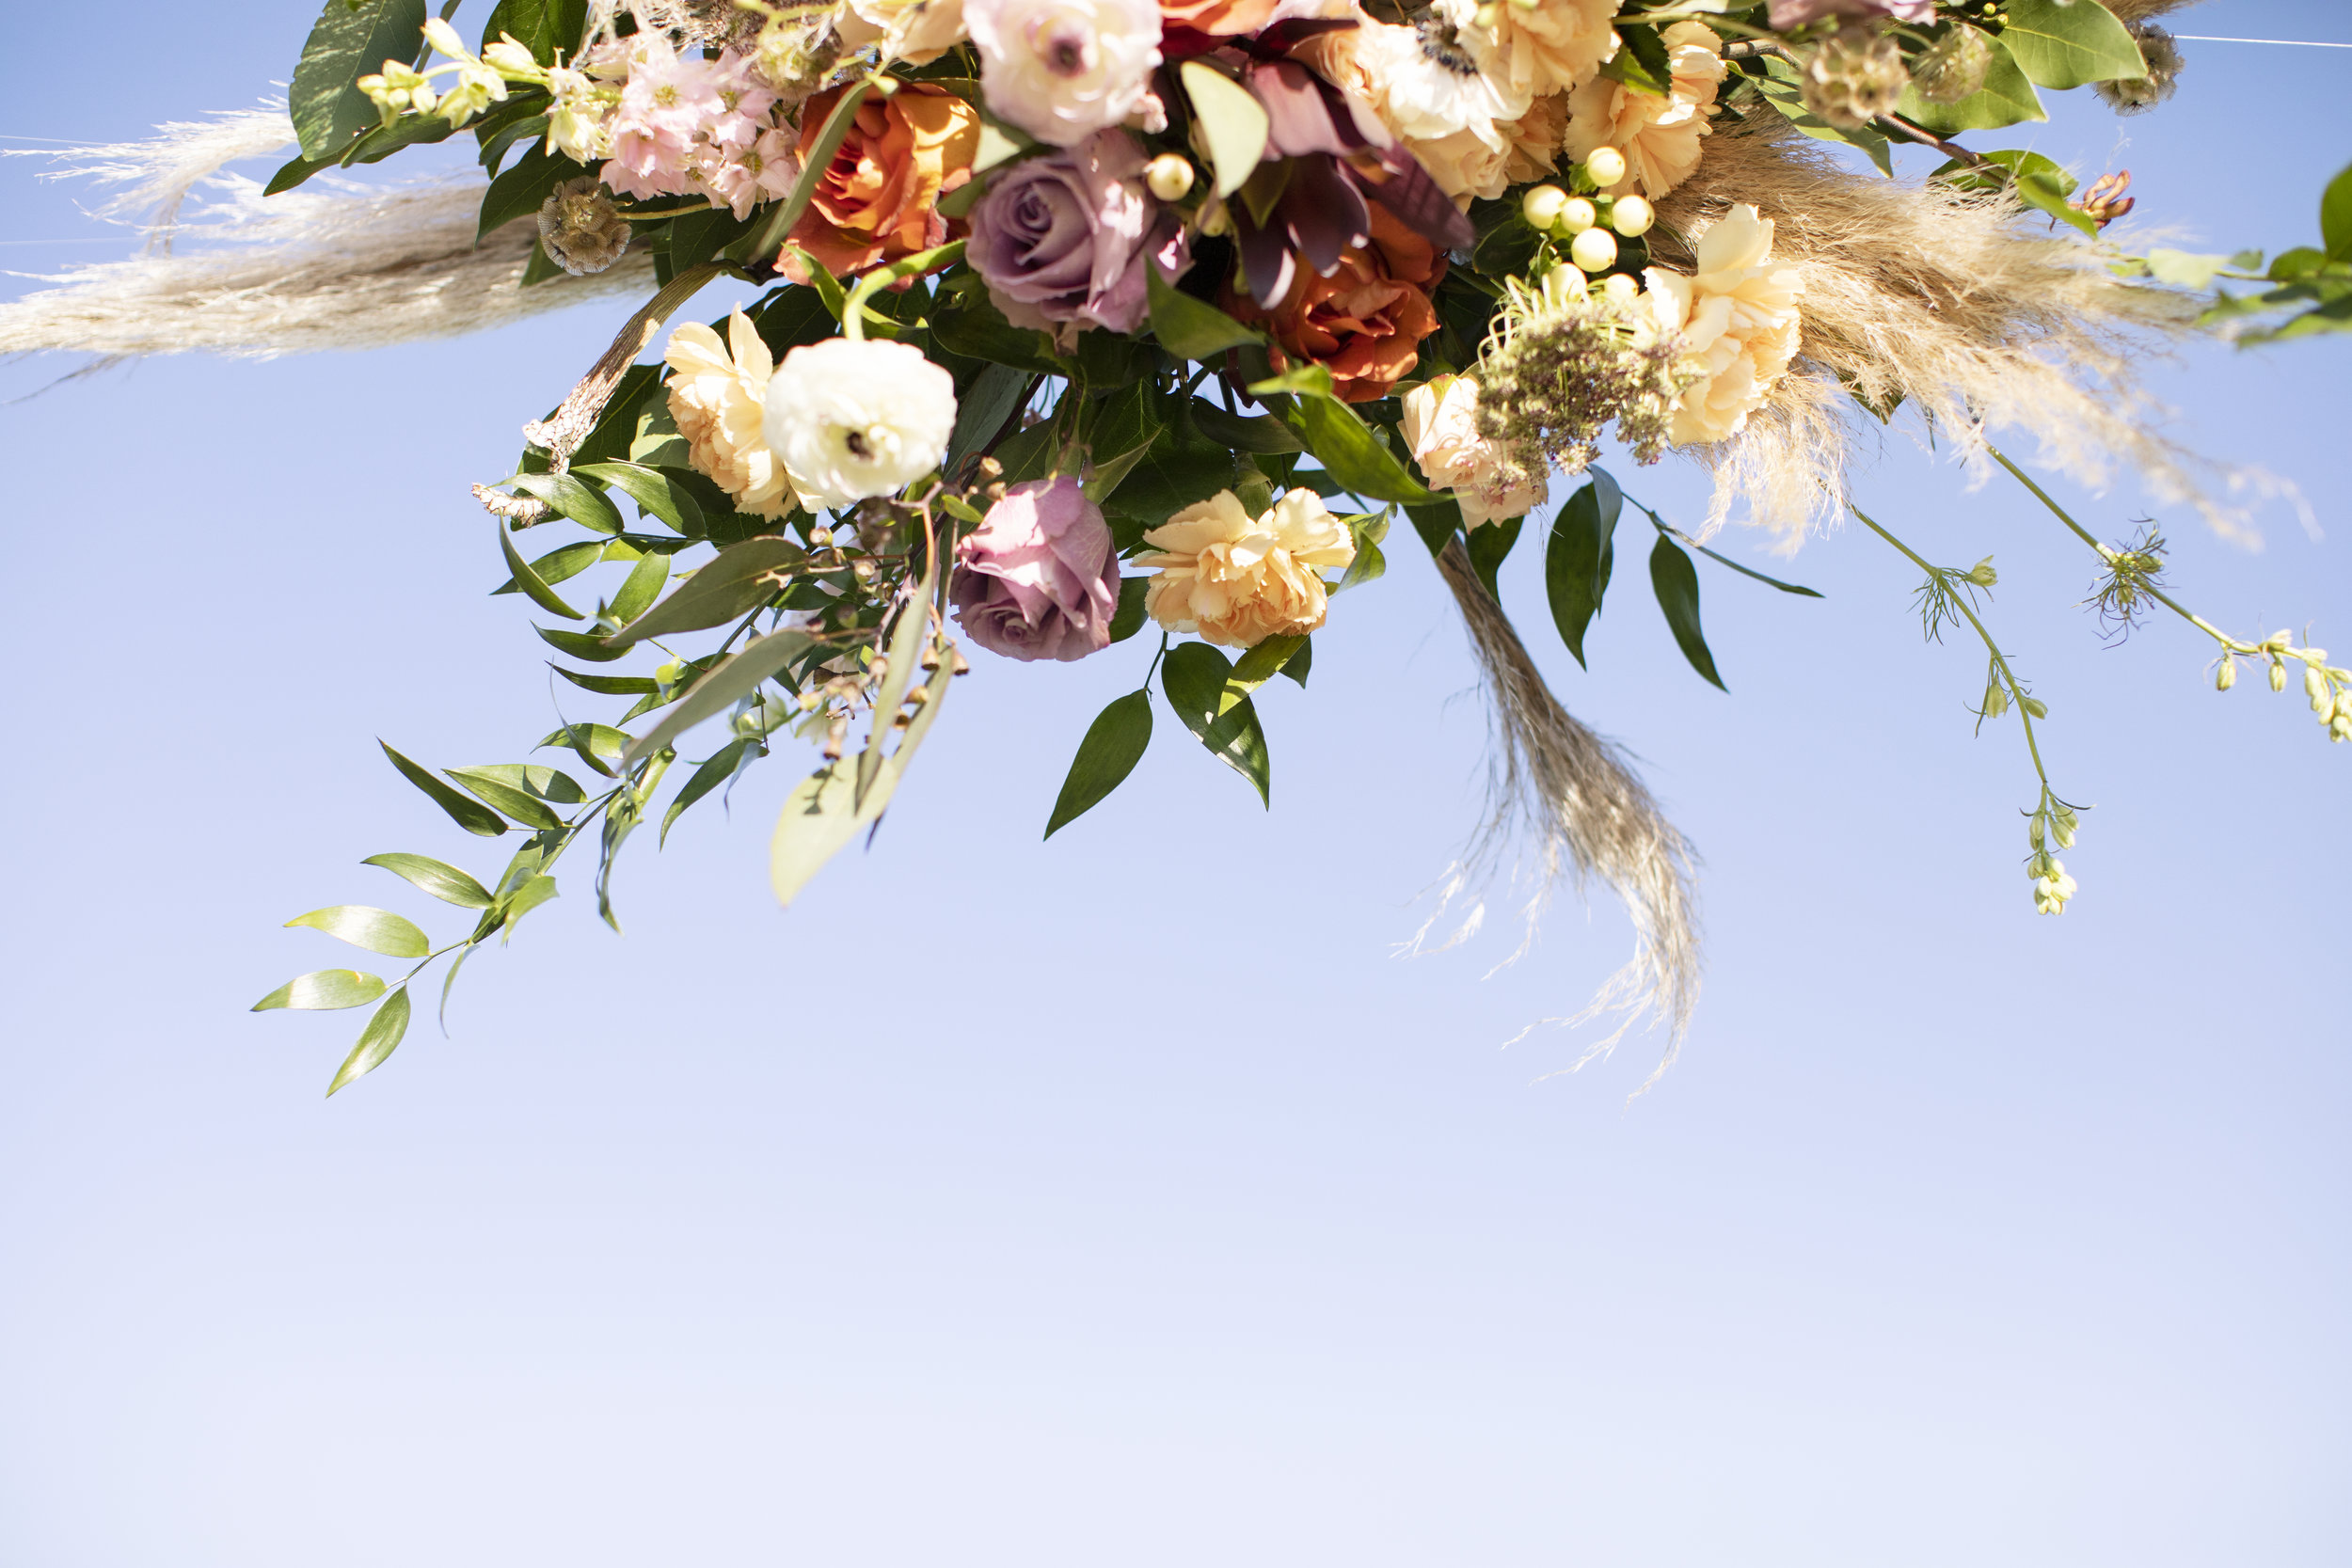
[948,477,1120,663]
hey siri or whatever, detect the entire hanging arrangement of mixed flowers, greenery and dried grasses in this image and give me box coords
[0,0,2352,1093]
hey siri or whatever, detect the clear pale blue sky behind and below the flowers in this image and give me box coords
[0,0,2352,1568]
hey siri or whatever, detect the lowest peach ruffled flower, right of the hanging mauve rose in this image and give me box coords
[1136,489,1355,649]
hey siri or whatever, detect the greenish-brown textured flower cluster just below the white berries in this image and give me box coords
[1477,265,1698,474]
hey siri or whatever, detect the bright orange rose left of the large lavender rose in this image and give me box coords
[779,82,981,282]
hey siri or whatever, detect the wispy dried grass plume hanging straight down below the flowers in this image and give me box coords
[1406,538,1698,1088]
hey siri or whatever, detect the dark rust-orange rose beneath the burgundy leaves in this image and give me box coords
[1223,202,1447,402]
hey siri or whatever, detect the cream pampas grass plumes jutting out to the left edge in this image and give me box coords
[0,103,652,373]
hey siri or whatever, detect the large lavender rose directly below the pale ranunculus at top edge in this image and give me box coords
[967,129,1193,341]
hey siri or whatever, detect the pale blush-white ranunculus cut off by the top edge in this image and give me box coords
[964,0,1160,148]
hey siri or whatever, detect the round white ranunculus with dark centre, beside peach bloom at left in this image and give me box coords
[760,339,955,510]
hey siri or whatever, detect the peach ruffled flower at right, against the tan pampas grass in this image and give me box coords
[1642,207,1804,447]
